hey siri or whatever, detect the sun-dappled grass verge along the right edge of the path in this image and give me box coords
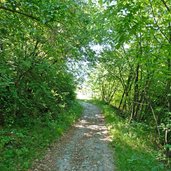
[94,103,171,171]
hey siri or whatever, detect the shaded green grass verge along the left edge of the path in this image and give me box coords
[0,103,82,171]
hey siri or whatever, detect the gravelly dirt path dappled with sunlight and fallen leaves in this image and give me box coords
[32,102,115,171]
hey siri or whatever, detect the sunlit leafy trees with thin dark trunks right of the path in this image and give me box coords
[89,0,171,158]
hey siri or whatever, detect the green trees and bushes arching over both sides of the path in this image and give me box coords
[0,0,171,169]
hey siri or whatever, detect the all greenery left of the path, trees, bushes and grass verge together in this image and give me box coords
[0,0,89,171]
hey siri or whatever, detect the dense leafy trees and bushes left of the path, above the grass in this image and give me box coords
[0,0,89,125]
